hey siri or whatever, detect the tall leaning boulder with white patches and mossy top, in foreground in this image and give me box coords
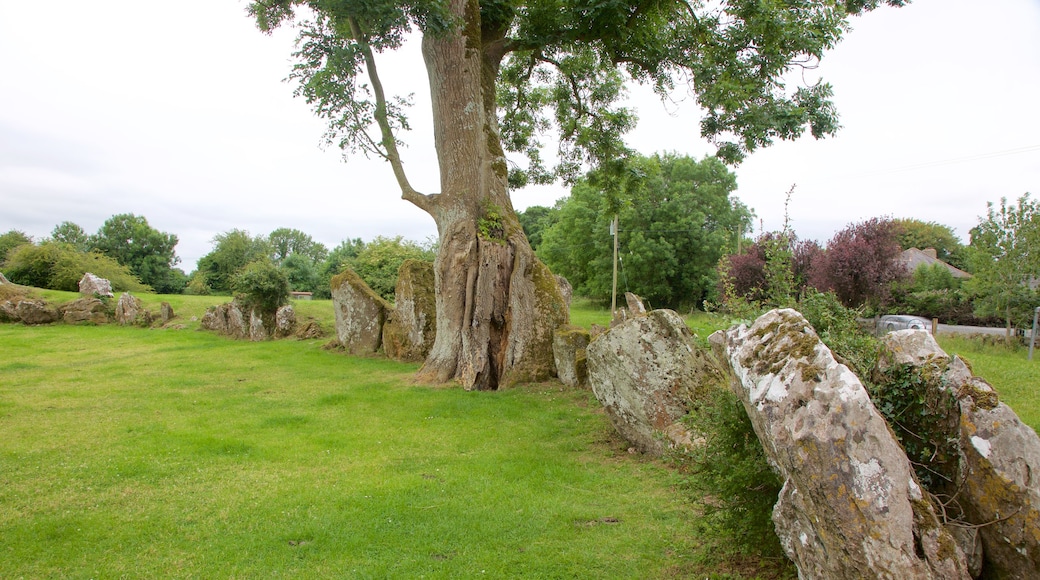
[710,309,969,579]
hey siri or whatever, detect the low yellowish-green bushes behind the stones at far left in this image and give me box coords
[4,241,152,292]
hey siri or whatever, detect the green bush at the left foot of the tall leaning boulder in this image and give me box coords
[676,387,783,557]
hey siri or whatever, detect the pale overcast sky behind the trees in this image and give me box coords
[0,0,1040,271]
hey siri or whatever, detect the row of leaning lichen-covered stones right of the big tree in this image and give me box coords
[586,299,1040,579]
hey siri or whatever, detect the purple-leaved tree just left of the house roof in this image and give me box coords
[809,217,909,308]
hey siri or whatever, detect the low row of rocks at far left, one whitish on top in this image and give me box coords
[0,272,174,326]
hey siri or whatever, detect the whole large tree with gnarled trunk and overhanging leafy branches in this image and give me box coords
[250,0,905,389]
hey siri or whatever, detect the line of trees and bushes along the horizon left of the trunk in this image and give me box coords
[0,218,435,300]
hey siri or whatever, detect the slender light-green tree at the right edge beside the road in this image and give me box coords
[966,193,1040,339]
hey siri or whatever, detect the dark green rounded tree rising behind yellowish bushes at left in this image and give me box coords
[90,213,184,294]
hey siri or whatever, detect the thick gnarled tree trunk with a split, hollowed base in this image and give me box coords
[409,0,568,390]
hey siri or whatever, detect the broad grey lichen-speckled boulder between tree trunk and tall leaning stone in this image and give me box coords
[587,310,722,455]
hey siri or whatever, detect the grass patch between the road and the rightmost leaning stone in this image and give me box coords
[938,335,1040,432]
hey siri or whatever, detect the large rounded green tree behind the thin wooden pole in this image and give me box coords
[539,154,751,308]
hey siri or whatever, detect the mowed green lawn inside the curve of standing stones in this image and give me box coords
[0,324,717,578]
